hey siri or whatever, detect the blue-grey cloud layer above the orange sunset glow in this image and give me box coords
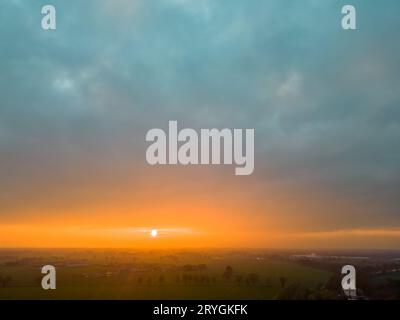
[0,0,400,226]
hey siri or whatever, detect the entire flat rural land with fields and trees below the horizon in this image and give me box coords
[0,249,400,300]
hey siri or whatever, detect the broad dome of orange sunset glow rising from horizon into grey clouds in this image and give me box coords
[0,170,400,249]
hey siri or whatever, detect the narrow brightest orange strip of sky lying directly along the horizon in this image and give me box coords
[0,225,400,249]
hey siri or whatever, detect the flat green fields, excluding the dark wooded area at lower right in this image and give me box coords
[0,253,331,299]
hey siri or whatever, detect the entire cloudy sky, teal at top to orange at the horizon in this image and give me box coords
[0,0,400,248]
